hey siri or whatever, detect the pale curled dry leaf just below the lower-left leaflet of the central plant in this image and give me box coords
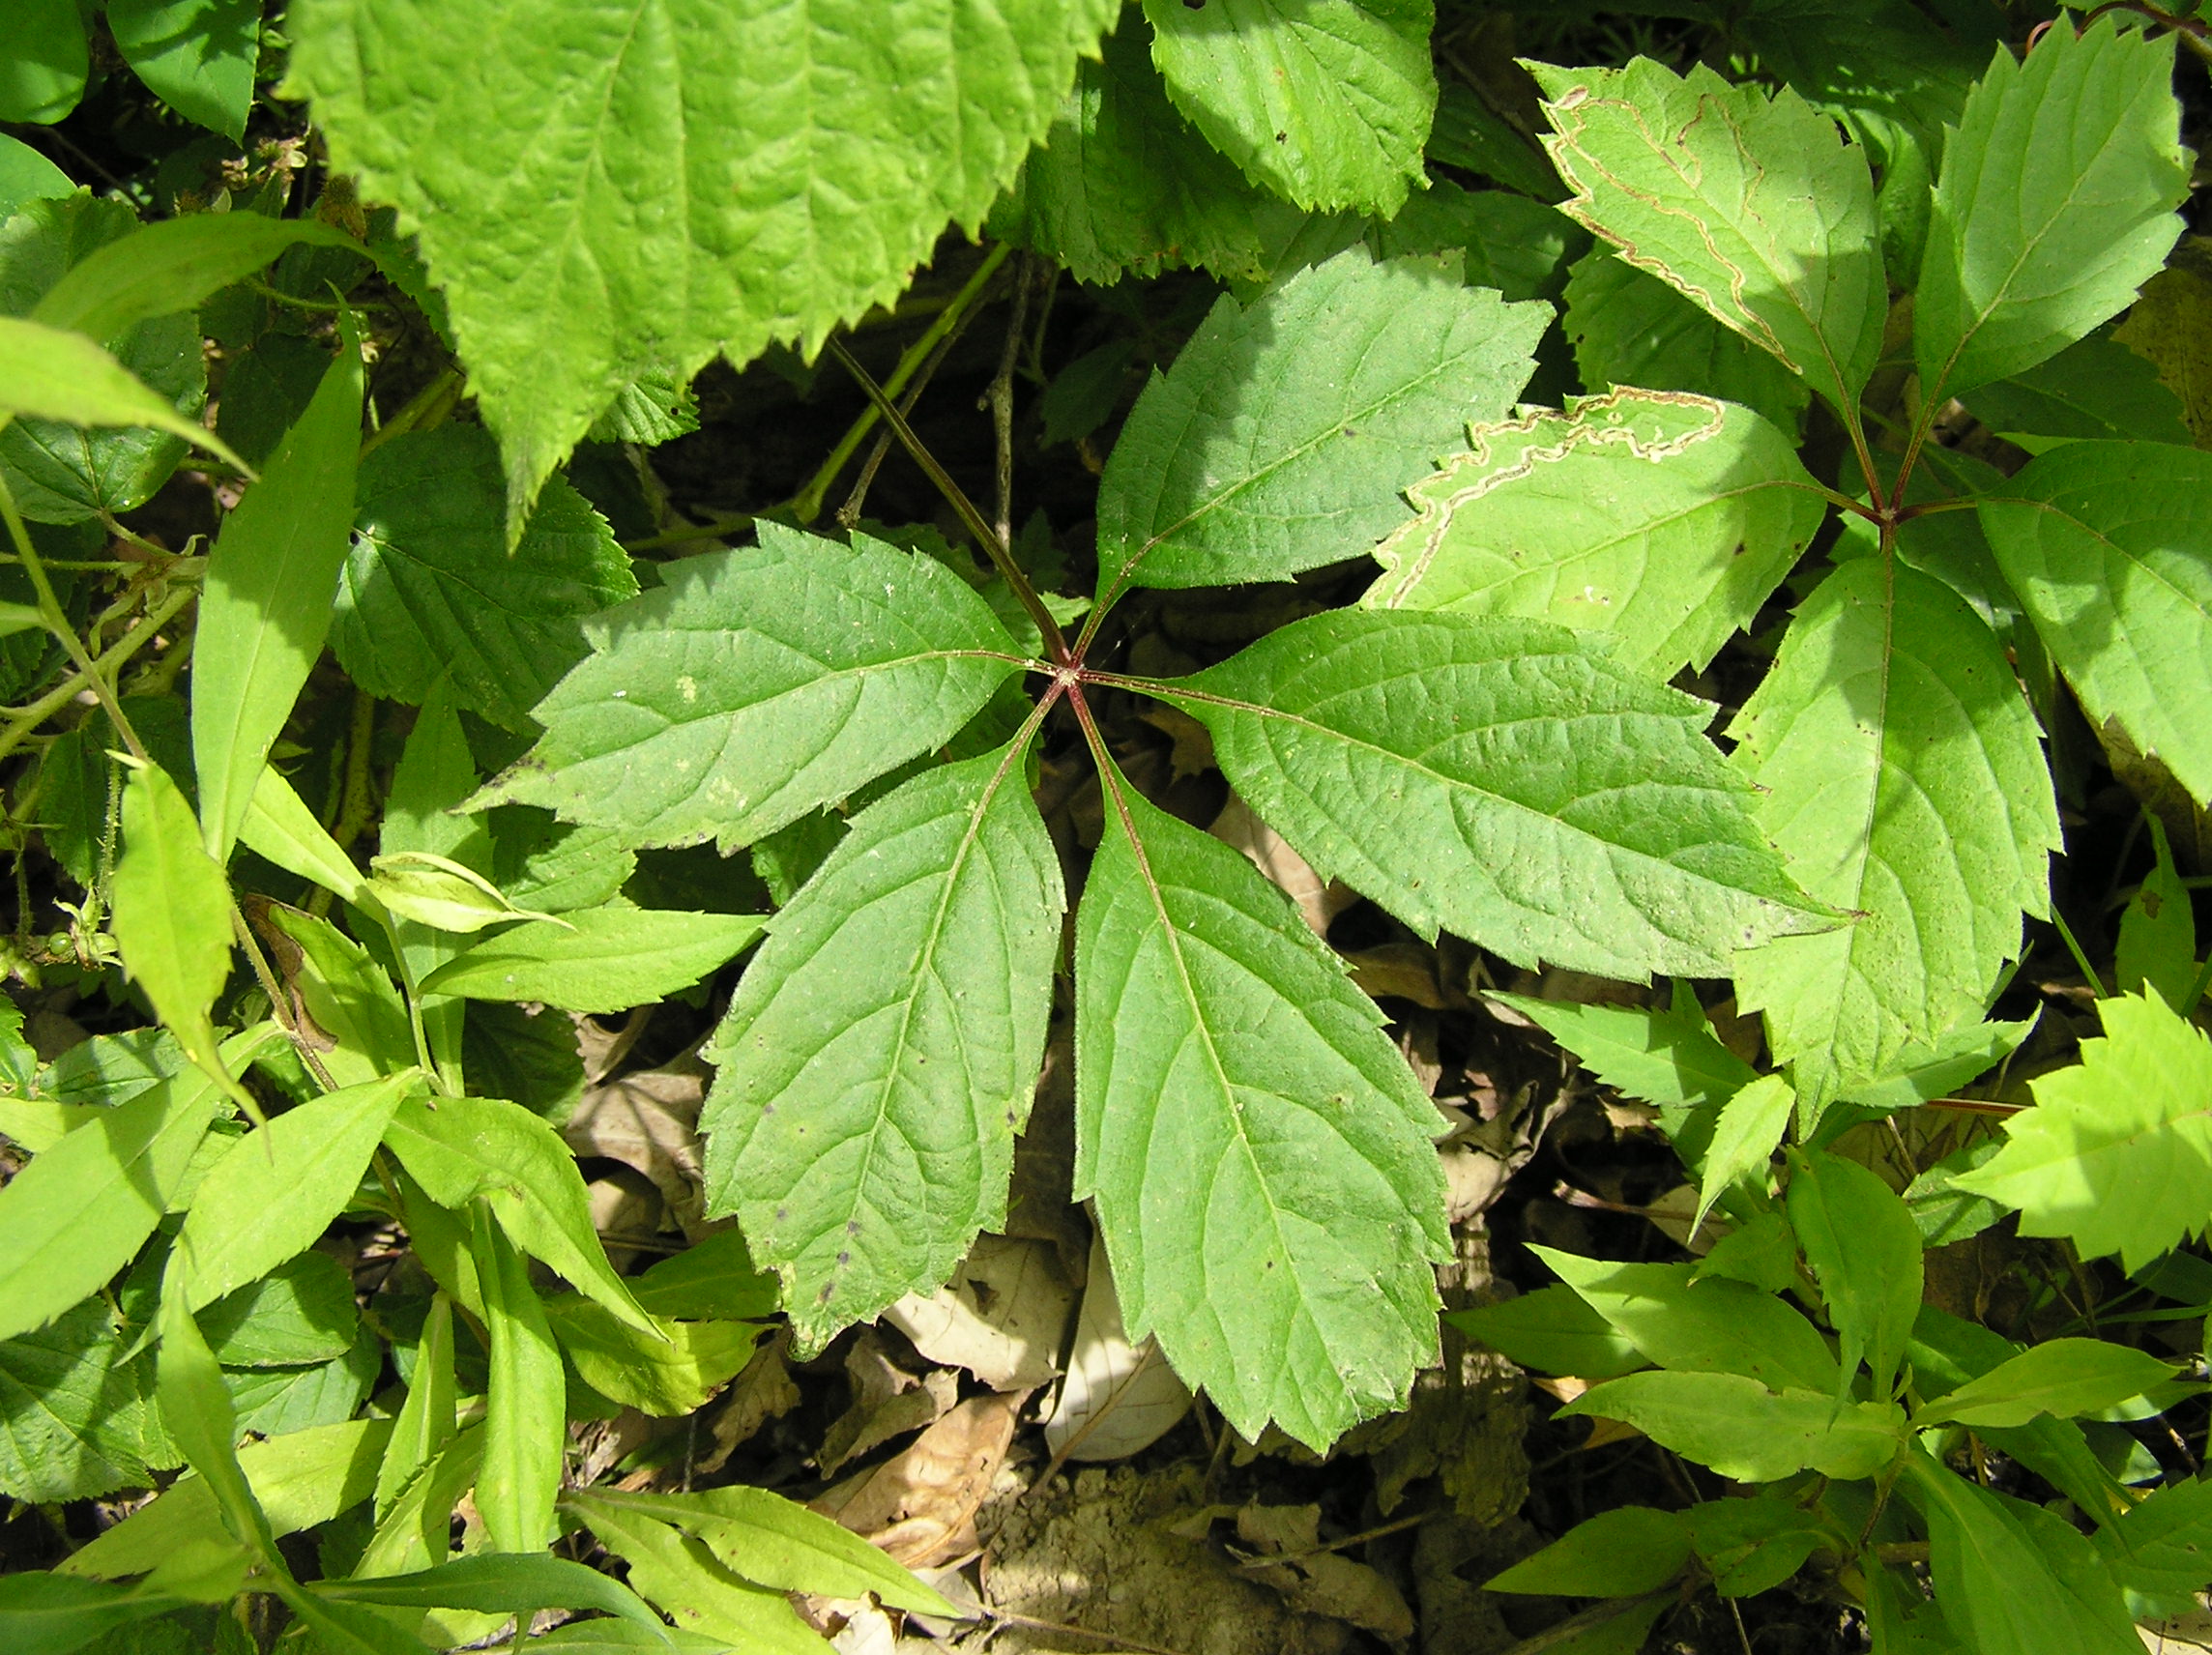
[883,1234,1075,1392]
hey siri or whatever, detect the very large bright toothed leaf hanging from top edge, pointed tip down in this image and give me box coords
[285,0,1115,539]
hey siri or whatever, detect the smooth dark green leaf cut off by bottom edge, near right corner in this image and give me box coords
[1898,1454,2143,1655]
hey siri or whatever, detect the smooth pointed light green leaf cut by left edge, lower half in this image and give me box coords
[0,1061,228,1339]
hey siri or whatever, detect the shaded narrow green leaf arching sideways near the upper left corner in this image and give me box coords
[31,211,361,345]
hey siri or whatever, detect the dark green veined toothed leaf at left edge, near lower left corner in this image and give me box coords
[0,1299,177,1504]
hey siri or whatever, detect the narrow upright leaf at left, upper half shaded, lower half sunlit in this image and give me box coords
[189,330,363,865]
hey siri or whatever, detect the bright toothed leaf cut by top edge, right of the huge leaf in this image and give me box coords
[1144,0,1436,217]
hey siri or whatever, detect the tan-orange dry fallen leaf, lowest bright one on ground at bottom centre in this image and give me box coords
[812,1392,1027,1569]
